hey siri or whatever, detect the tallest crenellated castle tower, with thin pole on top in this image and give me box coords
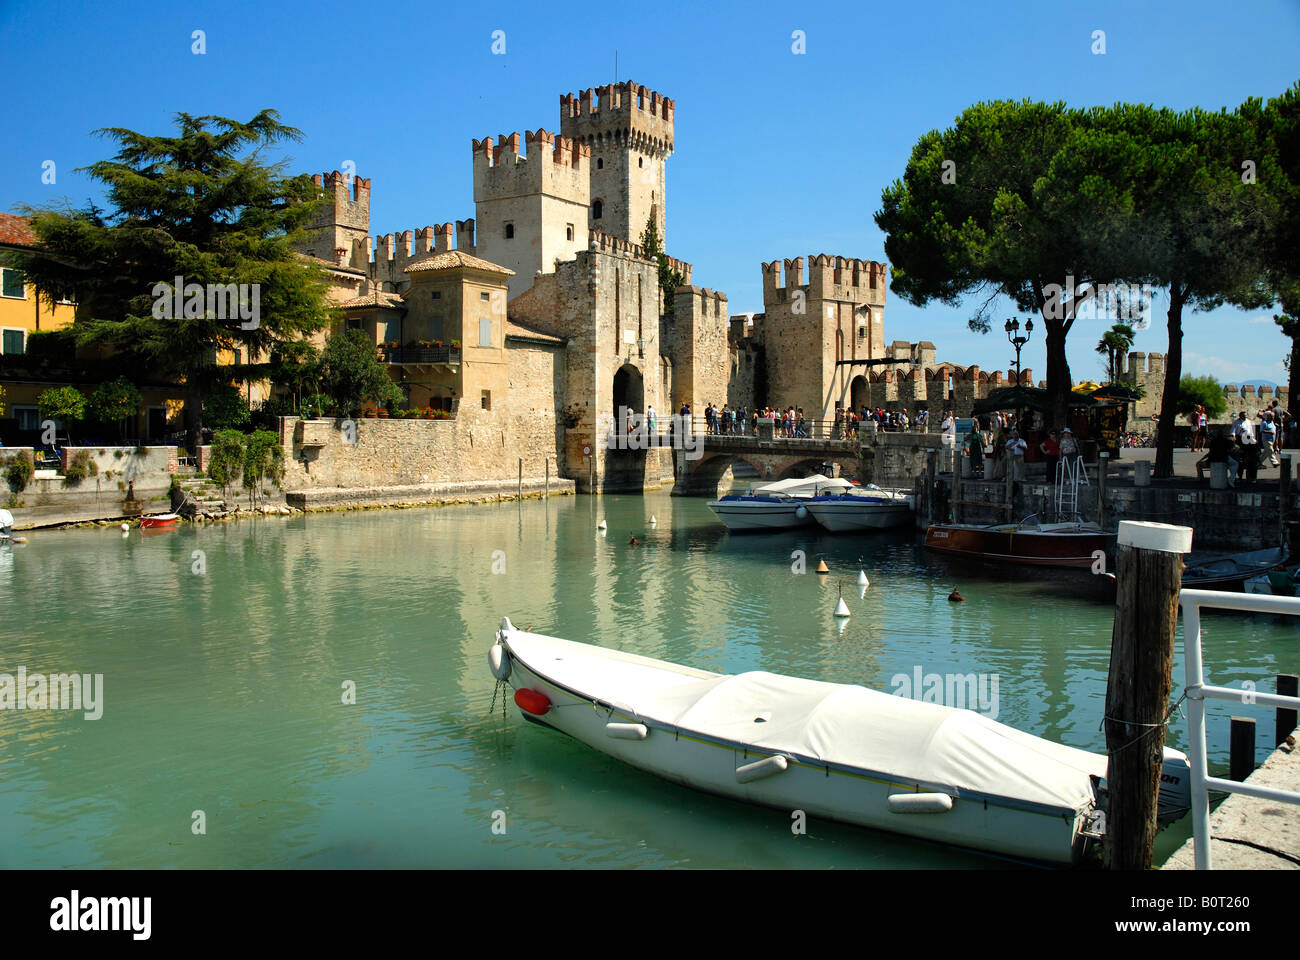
[560,81,675,246]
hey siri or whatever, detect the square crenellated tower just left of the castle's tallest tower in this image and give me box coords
[473,130,590,298]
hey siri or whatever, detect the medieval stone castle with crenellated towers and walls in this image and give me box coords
[289,82,1050,489]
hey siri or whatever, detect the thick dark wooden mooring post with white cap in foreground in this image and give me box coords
[1105,520,1192,870]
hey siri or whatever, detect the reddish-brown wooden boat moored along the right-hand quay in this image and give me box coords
[926,516,1115,567]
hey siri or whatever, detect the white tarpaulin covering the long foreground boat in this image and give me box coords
[503,631,1106,810]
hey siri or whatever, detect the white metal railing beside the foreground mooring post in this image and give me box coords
[1178,582,1300,870]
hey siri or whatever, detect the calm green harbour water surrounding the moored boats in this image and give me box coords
[0,496,1300,868]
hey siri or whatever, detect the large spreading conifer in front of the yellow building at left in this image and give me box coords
[13,111,328,449]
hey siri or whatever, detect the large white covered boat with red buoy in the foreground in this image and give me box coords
[489,619,1191,862]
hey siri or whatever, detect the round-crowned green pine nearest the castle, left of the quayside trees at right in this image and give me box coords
[875,100,1097,423]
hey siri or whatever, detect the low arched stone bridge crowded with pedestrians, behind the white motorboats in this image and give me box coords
[672,433,943,497]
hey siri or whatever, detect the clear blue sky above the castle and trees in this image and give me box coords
[0,0,1300,382]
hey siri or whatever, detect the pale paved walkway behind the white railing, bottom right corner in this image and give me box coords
[1161,718,1300,870]
